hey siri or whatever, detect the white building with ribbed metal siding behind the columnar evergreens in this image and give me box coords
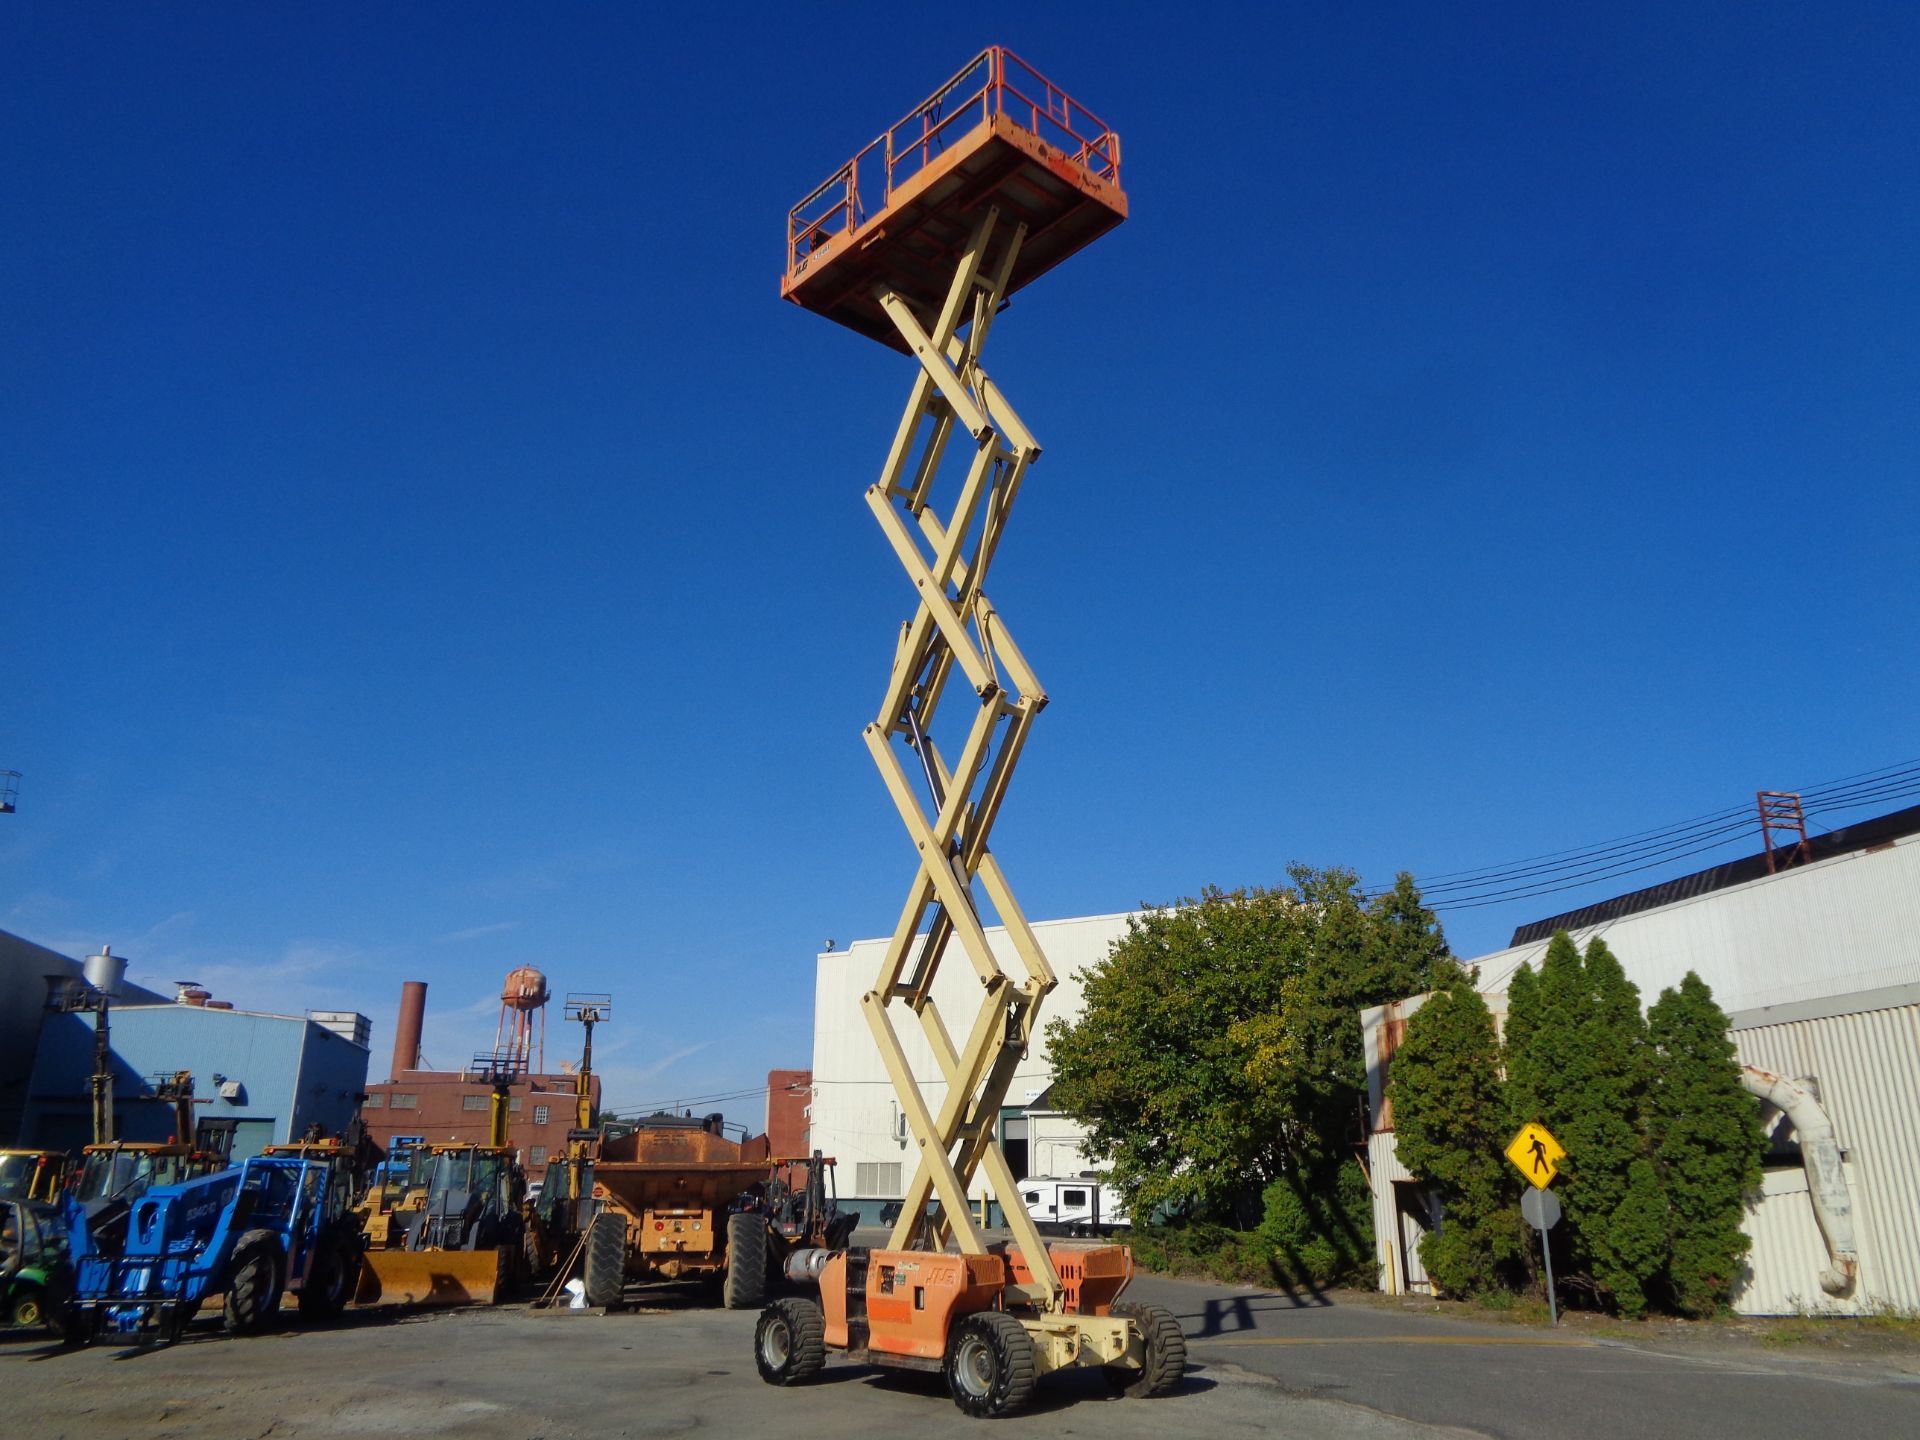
[1361,808,1920,1315]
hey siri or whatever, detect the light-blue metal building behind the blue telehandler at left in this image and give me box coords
[21,987,367,1160]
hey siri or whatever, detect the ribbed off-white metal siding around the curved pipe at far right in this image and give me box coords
[1734,1004,1920,1315]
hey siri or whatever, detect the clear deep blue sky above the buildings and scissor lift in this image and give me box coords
[0,4,1920,1119]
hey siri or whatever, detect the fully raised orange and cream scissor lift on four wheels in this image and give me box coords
[755,48,1187,1415]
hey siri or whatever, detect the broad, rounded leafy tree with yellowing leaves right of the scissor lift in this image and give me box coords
[1046,866,1446,1271]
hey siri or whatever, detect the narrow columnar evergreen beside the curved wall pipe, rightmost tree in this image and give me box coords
[1647,970,1763,1315]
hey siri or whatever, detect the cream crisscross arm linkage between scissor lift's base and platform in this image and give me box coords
[860,207,1060,1311]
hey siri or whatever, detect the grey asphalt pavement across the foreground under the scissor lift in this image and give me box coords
[0,1277,1920,1440]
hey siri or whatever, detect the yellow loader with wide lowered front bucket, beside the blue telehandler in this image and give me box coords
[353,1052,526,1306]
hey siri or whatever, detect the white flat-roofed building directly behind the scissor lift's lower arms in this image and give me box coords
[812,914,1127,1219]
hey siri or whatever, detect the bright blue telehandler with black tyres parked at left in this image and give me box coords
[65,1156,363,1344]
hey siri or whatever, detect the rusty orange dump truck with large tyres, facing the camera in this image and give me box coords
[540,1116,854,1309]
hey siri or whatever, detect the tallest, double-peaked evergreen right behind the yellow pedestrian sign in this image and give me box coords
[1507,931,1667,1315]
